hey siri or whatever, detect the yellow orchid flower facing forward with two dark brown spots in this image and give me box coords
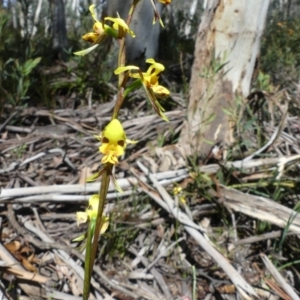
[95,119,137,165]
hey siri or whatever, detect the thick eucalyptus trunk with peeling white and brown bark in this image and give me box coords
[179,0,269,156]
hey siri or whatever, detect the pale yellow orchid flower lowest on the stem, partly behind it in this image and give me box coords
[76,195,109,234]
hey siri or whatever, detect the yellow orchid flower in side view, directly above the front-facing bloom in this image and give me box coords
[115,58,170,121]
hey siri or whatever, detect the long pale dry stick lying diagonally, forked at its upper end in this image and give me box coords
[137,161,257,300]
